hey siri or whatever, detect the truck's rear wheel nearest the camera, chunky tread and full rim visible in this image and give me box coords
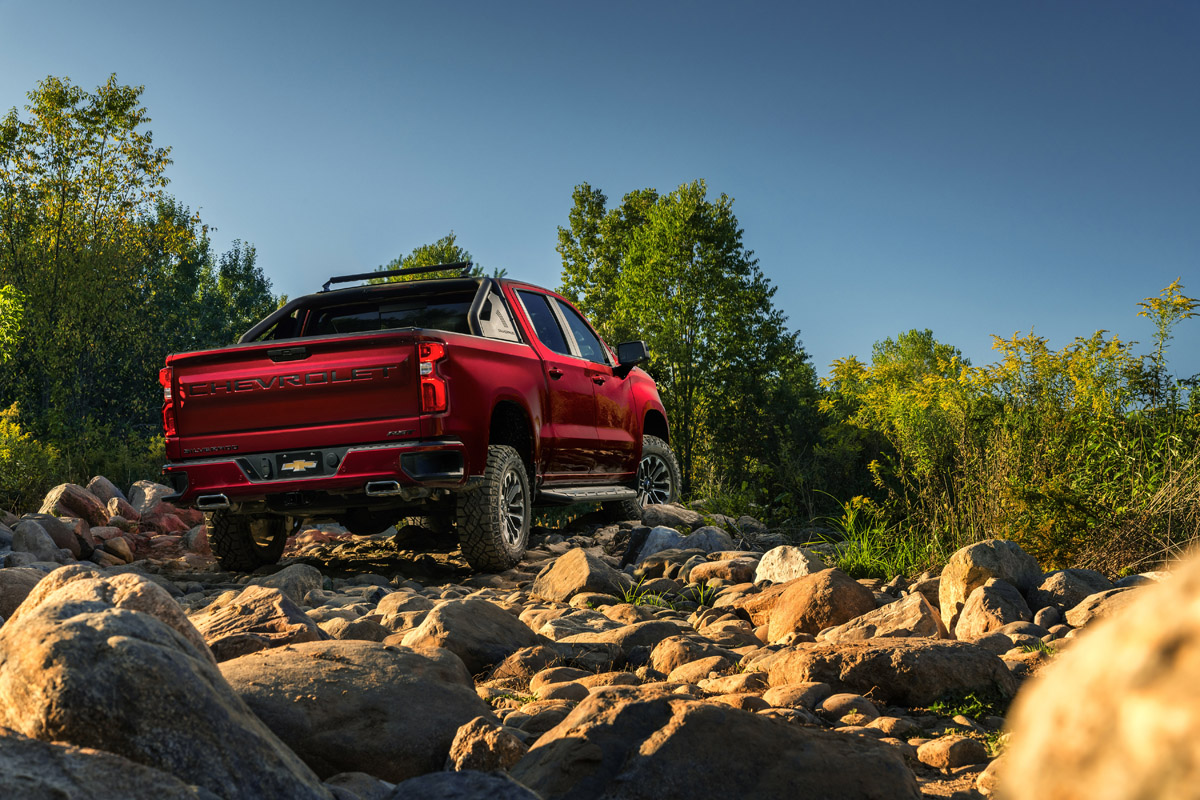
[457,445,533,572]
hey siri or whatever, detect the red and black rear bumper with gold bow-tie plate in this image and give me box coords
[162,439,468,505]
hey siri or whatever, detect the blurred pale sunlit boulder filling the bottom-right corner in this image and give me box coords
[1000,560,1200,800]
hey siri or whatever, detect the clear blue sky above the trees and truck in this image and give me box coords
[0,0,1200,375]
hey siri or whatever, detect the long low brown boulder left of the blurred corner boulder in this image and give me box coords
[757,639,1016,708]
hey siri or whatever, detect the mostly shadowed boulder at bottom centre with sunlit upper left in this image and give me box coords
[511,687,920,800]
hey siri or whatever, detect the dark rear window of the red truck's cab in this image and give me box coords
[305,291,475,336]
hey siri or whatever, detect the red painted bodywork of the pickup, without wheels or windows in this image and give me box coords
[163,279,666,504]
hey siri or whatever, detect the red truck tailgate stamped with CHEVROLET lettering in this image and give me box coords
[167,330,420,453]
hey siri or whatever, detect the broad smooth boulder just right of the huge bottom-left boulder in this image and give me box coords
[221,640,494,782]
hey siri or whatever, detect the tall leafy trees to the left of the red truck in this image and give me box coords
[0,76,277,470]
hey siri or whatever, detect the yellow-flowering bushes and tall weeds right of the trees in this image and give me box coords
[823,281,1200,571]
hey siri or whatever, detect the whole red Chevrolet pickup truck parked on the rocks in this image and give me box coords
[160,264,680,571]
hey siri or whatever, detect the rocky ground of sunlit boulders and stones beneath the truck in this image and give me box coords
[0,477,1180,800]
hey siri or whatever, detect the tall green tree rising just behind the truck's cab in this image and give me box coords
[558,181,814,501]
